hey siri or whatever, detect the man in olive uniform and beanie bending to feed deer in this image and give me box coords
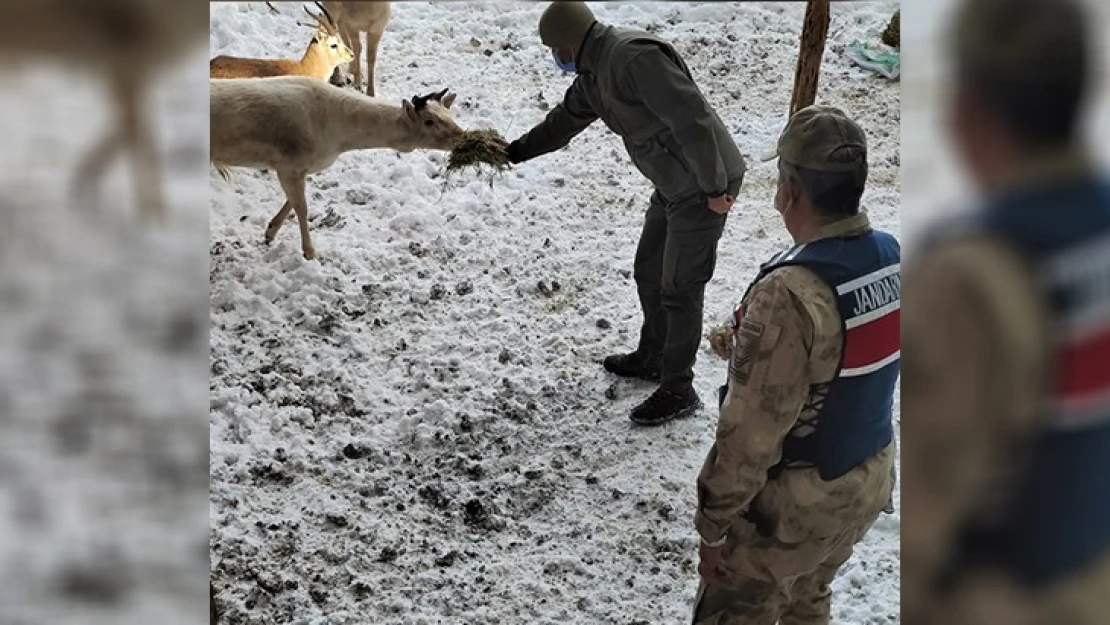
[508,2,745,424]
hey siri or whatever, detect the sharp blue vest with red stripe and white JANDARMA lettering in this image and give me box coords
[736,230,901,481]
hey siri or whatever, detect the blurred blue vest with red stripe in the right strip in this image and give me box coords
[935,173,1110,587]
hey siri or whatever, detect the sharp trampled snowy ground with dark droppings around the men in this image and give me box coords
[210,2,899,625]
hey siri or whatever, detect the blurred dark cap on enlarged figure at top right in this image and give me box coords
[947,0,1089,85]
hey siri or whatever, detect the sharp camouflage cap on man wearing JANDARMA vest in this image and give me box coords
[763,104,867,172]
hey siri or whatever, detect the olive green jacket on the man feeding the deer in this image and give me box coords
[513,22,746,199]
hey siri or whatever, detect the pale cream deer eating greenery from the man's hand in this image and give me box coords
[210,77,464,260]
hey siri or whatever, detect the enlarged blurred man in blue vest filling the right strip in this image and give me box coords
[901,0,1110,625]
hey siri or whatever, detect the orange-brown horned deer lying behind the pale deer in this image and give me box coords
[209,2,354,80]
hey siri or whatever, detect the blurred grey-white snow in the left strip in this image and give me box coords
[0,41,209,625]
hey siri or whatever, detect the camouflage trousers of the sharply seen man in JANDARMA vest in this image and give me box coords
[693,514,878,625]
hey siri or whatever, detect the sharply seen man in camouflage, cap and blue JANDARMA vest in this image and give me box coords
[694,105,900,625]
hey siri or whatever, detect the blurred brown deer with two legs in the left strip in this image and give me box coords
[0,0,209,218]
